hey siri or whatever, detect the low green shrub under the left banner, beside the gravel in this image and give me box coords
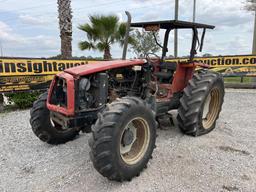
[5,91,42,109]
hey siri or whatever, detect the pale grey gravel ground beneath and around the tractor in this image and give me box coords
[0,89,256,192]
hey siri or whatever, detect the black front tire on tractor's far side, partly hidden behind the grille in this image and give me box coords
[30,92,79,145]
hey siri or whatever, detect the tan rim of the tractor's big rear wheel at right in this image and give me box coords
[202,88,220,129]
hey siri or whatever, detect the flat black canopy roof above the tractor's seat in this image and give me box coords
[131,20,215,29]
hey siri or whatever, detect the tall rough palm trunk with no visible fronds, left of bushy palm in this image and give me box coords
[57,0,72,59]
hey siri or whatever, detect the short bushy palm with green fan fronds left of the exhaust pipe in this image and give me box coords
[78,15,133,60]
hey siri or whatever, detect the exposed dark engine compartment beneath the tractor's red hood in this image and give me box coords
[76,65,146,111]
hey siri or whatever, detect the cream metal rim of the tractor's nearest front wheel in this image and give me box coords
[120,118,150,165]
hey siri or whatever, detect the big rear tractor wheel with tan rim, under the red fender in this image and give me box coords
[177,69,225,136]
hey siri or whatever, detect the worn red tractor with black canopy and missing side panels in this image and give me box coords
[30,13,224,181]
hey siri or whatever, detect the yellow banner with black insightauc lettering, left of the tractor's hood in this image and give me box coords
[0,58,100,93]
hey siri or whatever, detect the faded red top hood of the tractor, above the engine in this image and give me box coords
[65,59,146,77]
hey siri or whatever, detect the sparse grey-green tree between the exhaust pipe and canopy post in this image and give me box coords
[131,29,160,57]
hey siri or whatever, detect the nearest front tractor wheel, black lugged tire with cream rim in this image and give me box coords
[89,97,157,181]
